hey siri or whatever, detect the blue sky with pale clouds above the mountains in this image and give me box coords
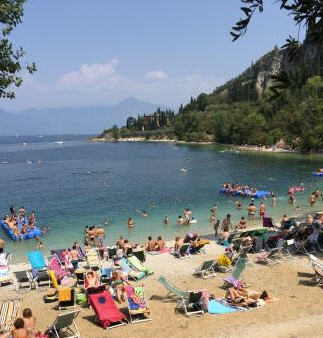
[1,0,304,110]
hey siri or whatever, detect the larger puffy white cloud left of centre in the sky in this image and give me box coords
[58,58,119,88]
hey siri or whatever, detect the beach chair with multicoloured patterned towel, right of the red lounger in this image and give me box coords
[125,285,151,324]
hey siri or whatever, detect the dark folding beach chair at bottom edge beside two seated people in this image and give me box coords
[47,311,81,338]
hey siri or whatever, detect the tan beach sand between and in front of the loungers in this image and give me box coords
[0,242,323,338]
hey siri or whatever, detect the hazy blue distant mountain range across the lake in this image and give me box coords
[0,98,159,136]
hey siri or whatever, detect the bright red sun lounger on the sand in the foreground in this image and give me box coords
[89,290,128,329]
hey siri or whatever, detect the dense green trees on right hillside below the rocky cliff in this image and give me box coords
[175,76,323,152]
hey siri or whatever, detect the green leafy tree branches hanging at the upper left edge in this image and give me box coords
[0,0,36,99]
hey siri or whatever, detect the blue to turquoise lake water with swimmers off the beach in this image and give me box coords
[0,137,323,257]
